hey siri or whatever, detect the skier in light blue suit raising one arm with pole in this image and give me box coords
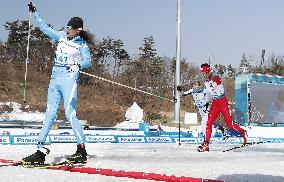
[22,3,93,164]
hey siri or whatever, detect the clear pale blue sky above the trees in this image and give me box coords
[0,0,284,66]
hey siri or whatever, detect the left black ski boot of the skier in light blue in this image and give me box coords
[22,147,50,165]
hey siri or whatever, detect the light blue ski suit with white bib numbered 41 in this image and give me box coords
[33,11,91,149]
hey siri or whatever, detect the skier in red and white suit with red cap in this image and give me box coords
[198,63,247,152]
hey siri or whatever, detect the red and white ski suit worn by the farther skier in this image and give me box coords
[205,75,245,144]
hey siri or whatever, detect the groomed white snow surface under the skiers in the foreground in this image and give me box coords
[0,143,284,182]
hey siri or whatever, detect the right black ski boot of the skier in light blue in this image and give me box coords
[66,144,87,164]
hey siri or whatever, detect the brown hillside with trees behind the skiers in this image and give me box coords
[0,20,284,126]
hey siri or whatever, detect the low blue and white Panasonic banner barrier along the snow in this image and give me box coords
[0,135,284,145]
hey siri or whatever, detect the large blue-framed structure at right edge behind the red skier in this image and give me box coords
[235,74,284,126]
